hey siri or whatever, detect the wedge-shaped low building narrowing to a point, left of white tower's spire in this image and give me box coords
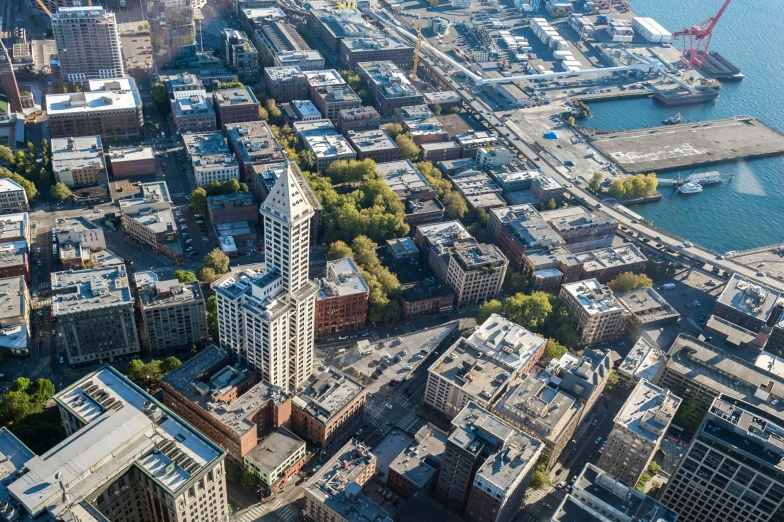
[119,181,182,262]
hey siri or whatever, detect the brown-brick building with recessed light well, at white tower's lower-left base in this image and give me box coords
[161,346,291,463]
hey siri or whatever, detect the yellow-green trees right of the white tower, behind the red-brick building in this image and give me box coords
[327,236,402,324]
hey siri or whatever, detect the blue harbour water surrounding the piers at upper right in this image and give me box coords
[586,0,784,252]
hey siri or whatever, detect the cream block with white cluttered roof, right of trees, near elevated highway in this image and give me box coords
[559,279,630,345]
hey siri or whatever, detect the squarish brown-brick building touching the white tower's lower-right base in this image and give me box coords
[291,368,366,449]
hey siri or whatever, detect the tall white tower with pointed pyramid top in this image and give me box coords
[212,165,318,389]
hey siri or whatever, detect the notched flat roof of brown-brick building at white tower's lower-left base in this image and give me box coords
[163,345,288,436]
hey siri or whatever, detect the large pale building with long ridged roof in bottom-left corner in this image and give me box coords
[0,365,228,522]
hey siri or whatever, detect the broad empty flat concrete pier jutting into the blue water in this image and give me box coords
[591,116,784,172]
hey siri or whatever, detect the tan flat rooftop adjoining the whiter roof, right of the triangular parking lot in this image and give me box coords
[428,338,516,401]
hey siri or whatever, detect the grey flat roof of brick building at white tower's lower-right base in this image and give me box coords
[293,368,365,424]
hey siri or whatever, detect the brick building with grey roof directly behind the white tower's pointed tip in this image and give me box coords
[225,121,286,181]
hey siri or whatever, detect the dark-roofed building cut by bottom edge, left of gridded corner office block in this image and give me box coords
[550,462,682,522]
